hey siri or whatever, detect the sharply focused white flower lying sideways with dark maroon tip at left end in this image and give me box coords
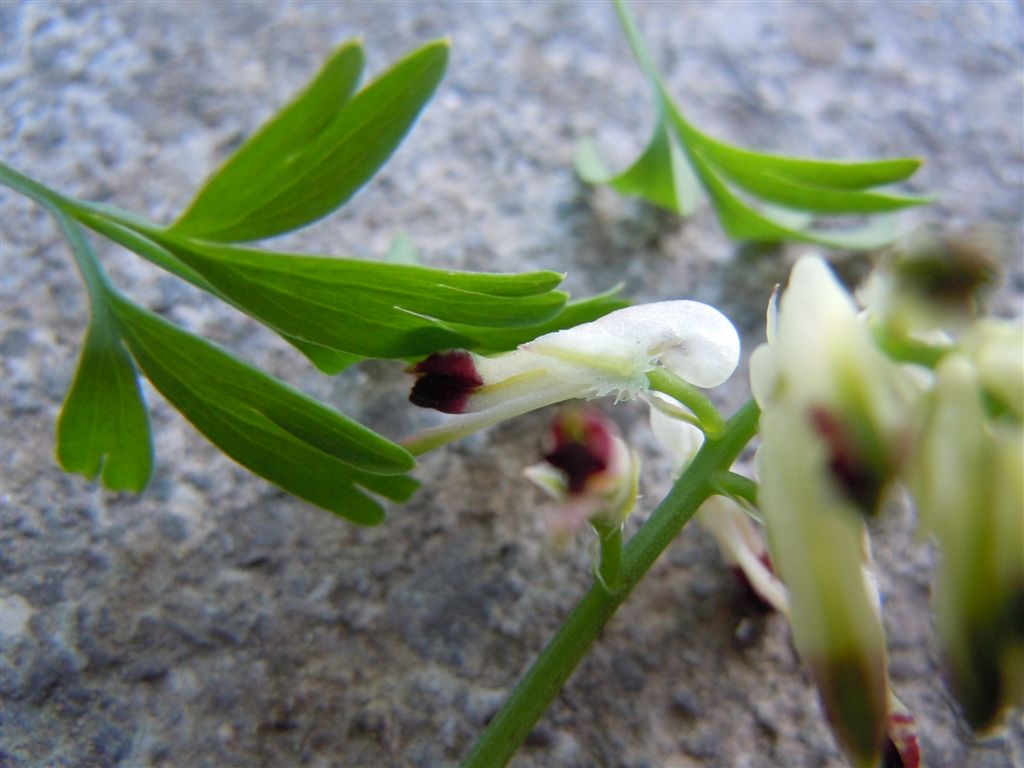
[404,301,739,454]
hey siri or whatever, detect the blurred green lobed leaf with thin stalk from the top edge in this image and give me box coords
[577,0,933,249]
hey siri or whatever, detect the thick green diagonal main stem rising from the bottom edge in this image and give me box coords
[463,400,760,768]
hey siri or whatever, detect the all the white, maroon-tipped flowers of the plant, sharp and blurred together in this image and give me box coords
[406,249,1024,768]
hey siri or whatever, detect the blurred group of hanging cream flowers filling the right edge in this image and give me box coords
[751,256,1024,766]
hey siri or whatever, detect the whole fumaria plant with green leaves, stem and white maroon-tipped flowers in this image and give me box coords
[0,2,1024,767]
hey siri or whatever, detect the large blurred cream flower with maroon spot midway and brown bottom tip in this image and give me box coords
[751,258,909,766]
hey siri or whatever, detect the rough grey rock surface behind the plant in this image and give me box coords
[0,1,1024,768]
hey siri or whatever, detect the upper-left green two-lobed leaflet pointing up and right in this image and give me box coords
[171,41,449,242]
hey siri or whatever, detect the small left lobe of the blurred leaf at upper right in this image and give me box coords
[575,120,697,216]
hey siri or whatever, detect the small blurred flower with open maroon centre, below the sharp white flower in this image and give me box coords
[524,409,640,546]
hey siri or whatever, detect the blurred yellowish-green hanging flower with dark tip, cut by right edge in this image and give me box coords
[910,354,1024,729]
